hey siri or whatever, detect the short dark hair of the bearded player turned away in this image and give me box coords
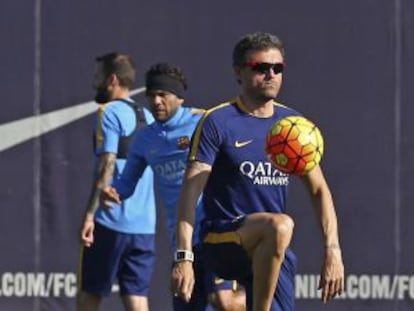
[96,52,136,89]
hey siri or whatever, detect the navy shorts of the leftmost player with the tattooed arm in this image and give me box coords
[78,222,155,296]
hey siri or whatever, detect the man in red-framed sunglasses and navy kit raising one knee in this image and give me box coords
[172,33,344,311]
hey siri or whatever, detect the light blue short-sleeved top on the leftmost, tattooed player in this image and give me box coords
[95,99,156,234]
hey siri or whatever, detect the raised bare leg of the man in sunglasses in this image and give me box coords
[237,213,294,311]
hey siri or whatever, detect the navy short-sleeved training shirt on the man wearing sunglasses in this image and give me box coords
[190,98,299,220]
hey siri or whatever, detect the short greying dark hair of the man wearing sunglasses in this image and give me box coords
[233,32,285,66]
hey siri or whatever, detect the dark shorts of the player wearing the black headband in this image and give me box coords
[173,246,241,311]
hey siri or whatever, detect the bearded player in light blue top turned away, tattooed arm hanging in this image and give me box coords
[77,53,156,311]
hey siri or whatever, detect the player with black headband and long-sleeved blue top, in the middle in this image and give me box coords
[103,63,245,311]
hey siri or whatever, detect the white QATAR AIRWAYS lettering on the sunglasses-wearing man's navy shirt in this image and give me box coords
[240,161,289,186]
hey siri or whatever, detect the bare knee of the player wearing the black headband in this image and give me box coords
[208,289,246,311]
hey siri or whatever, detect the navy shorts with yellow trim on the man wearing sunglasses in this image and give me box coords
[201,217,296,311]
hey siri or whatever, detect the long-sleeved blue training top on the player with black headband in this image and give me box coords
[115,107,204,248]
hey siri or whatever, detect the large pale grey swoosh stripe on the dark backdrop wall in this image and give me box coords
[0,87,145,151]
